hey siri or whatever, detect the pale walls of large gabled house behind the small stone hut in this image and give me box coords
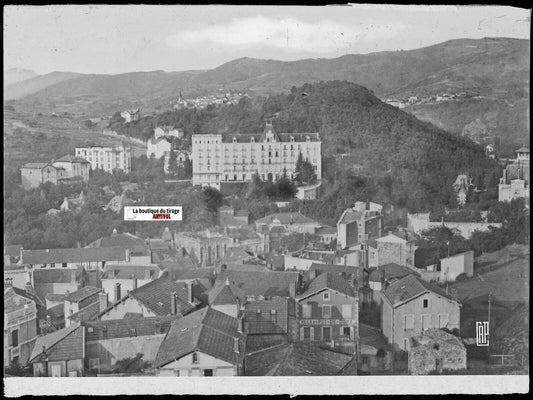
[383,293,460,350]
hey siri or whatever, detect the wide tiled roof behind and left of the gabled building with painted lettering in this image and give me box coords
[213,270,298,302]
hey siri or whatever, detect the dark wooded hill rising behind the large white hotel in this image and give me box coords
[119,81,498,211]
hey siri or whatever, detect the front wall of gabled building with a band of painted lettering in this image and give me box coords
[297,289,359,342]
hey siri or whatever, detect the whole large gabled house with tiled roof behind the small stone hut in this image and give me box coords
[381,275,461,351]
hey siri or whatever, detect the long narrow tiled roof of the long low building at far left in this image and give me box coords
[22,247,126,264]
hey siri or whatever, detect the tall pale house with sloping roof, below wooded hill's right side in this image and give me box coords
[337,201,383,249]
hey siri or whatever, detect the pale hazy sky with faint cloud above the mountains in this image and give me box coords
[3,5,531,74]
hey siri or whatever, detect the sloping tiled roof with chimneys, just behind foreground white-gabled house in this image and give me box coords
[129,273,198,315]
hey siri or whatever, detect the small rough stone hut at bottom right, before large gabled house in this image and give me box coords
[408,329,466,375]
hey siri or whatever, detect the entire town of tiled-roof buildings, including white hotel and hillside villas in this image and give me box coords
[4,110,529,377]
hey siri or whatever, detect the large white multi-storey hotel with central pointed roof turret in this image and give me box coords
[191,124,322,189]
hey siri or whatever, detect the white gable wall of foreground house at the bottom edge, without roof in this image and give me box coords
[158,352,238,376]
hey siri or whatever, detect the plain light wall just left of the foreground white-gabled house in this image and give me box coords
[85,334,165,372]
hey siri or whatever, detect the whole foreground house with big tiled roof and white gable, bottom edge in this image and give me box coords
[154,307,244,377]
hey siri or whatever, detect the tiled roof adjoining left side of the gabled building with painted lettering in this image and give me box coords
[244,299,289,335]
